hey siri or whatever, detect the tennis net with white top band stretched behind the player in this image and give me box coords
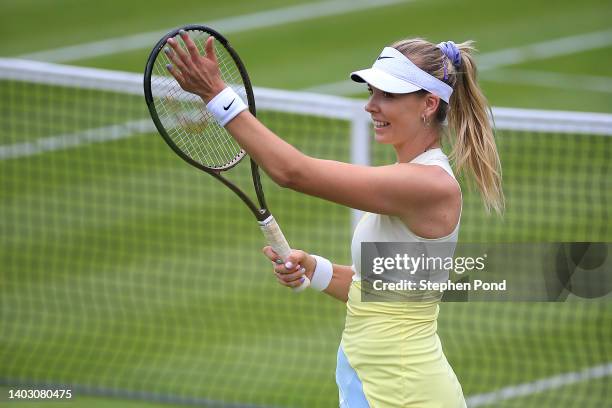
[0,62,612,407]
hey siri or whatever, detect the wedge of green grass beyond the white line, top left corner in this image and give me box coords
[0,0,300,56]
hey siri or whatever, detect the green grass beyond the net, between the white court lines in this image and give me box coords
[0,0,612,112]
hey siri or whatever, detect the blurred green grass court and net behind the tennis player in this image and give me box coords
[0,0,612,408]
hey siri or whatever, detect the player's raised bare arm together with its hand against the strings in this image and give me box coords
[168,33,451,216]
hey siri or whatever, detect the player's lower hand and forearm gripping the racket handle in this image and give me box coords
[263,246,354,302]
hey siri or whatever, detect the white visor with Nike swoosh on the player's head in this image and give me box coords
[351,47,453,103]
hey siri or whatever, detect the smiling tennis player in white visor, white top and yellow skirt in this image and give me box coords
[169,32,504,408]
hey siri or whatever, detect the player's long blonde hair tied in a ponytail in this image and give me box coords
[391,38,504,214]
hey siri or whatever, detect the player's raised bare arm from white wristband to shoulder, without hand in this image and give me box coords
[226,111,448,215]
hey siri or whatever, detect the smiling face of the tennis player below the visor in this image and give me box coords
[365,85,425,146]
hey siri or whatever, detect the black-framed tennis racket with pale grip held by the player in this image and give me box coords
[144,25,310,292]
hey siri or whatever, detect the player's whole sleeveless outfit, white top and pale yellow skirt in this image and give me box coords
[341,149,465,408]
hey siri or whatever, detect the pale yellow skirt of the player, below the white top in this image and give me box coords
[341,282,466,408]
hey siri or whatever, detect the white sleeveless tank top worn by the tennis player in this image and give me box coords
[351,148,461,281]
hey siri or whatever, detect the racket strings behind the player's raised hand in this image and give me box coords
[151,31,247,169]
